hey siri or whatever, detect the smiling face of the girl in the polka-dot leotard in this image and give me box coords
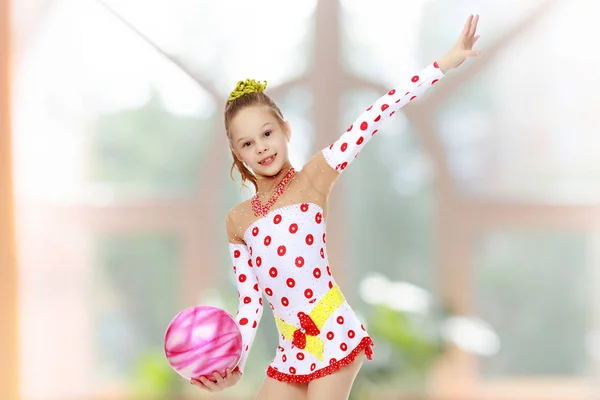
[230,106,291,176]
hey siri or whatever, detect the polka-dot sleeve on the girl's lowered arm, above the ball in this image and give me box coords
[229,243,263,373]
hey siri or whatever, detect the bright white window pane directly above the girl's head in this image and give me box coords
[95,0,316,93]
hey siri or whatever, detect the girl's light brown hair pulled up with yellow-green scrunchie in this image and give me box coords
[224,79,285,191]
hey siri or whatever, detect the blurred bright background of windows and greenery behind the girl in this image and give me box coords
[0,0,600,400]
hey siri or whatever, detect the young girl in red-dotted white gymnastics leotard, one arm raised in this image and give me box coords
[191,15,479,400]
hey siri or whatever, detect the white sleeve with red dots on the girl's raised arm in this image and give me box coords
[305,62,444,193]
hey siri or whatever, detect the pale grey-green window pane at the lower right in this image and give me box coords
[473,230,592,377]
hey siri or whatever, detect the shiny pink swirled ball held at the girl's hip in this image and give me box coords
[165,306,242,380]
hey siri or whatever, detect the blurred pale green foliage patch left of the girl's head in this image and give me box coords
[90,93,214,195]
